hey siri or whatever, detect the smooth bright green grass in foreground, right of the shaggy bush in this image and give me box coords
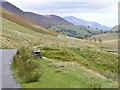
[21,55,117,88]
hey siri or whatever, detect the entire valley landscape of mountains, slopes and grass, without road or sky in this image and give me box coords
[0,1,119,89]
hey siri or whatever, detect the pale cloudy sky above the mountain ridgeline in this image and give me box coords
[7,0,119,27]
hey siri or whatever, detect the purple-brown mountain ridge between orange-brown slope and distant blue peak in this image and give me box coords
[23,12,72,28]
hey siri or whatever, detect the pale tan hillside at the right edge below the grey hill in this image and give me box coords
[88,33,119,53]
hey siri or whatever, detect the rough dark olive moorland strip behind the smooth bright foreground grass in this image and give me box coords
[42,46,118,81]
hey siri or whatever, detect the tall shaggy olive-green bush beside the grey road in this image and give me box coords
[12,48,40,83]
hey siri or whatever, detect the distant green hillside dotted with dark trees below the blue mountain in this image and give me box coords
[48,24,101,37]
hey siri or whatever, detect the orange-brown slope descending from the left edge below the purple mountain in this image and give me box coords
[2,8,56,35]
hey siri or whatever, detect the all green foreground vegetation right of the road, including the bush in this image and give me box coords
[12,45,117,88]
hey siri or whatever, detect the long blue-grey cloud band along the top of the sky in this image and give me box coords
[6,0,113,10]
